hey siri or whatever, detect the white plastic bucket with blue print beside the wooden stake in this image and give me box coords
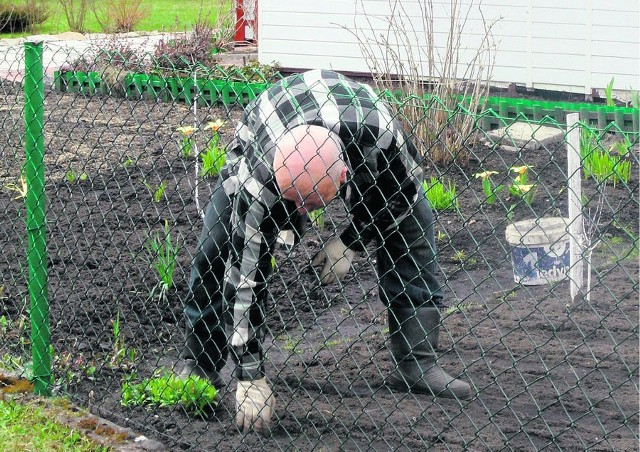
[505,217,570,286]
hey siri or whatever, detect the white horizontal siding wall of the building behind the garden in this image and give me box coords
[258,0,640,98]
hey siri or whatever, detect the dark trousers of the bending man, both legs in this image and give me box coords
[181,183,442,371]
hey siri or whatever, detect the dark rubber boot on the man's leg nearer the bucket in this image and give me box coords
[389,307,473,400]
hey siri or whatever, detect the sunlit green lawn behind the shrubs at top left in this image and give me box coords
[0,0,231,38]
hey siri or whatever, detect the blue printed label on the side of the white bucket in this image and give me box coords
[511,241,570,285]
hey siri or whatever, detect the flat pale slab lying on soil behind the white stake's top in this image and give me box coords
[487,122,564,151]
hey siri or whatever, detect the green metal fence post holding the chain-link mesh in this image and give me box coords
[24,42,51,395]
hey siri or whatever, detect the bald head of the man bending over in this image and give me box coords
[273,125,347,212]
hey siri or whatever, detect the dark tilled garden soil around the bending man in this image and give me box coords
[0,84,638,451]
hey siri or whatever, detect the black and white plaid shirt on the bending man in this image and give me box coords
[222,70,422,380]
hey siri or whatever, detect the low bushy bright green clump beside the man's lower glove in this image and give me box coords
[121,372,218,416]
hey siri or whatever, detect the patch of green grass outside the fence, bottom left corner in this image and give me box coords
[0,400,108,452]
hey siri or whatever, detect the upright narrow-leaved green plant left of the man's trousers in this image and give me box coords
[146,220,180,301]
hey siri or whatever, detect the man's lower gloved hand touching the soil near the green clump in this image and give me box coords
[236,378,276,435]
